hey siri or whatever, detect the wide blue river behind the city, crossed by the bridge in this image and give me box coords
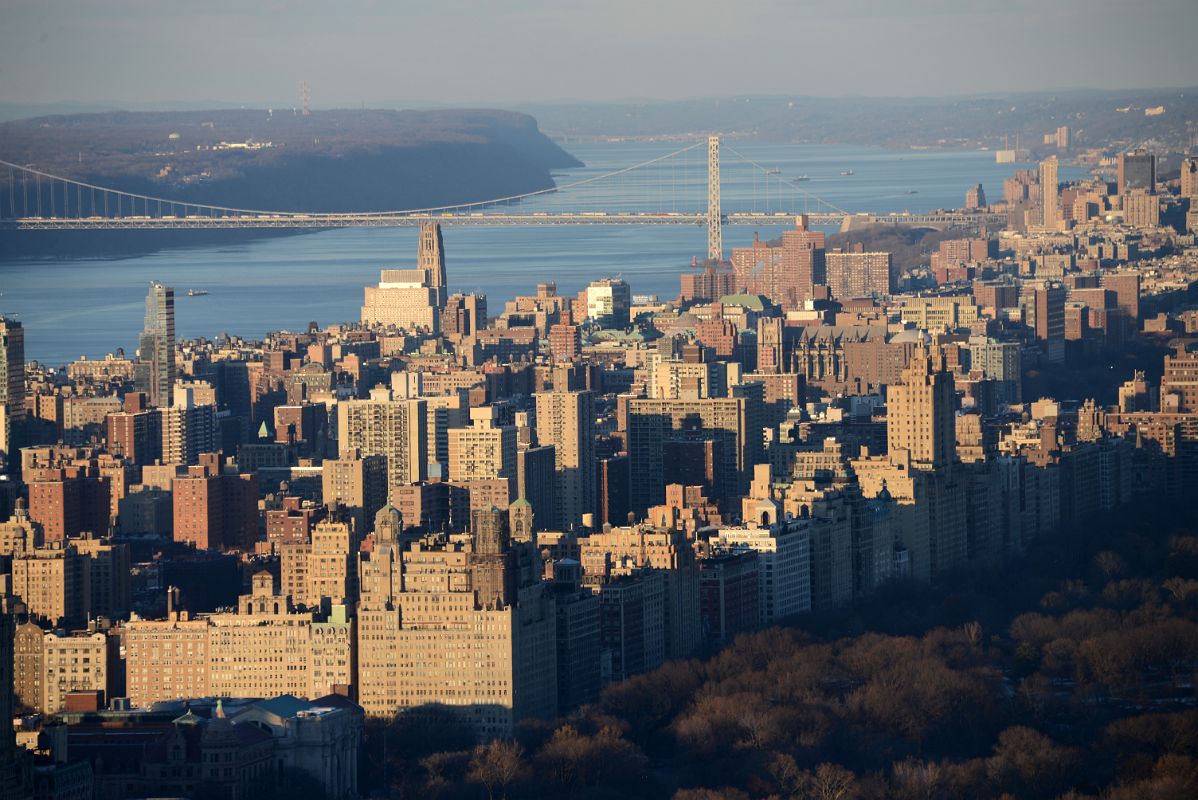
[0,143,1081,365]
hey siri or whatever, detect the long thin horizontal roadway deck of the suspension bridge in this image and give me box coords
[0,212,1006,231]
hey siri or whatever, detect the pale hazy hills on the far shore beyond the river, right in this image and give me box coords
[526,87,1198,150]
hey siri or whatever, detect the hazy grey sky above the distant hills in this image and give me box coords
[0,0,1198,108]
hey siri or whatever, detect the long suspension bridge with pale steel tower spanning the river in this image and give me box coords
[0,137,1005,259]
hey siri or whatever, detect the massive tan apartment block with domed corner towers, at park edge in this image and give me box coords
[357,505,557,738]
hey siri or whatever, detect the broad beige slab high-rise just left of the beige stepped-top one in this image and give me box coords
[337,387,429,492]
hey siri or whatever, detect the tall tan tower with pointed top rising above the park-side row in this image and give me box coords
[887,347,956,469]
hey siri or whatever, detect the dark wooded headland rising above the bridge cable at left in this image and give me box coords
[0,109,579,212]
